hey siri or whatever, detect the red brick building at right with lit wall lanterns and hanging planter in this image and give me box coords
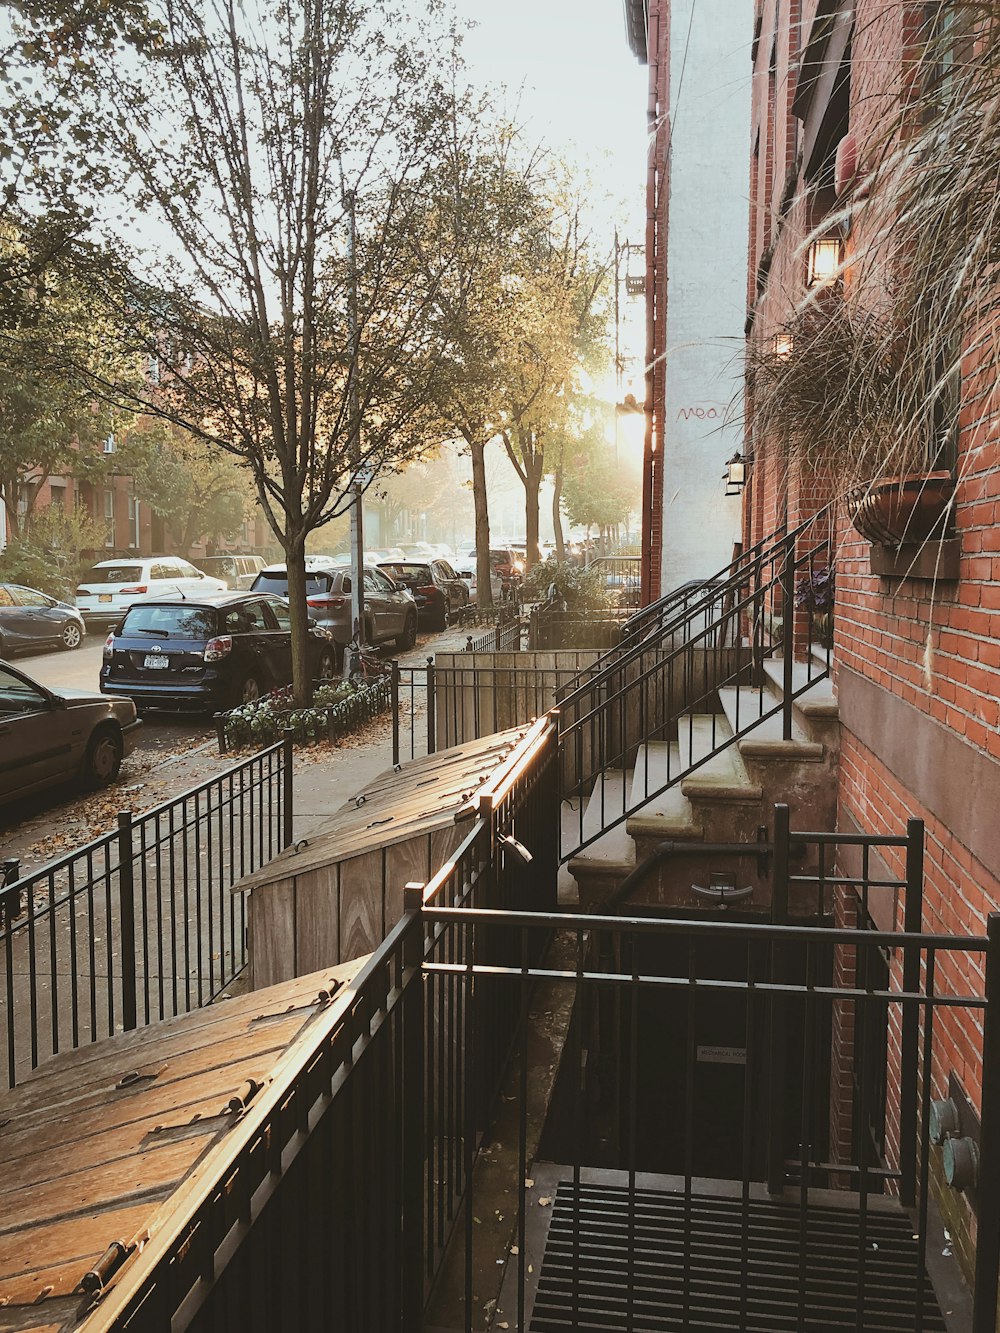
[744,0,1000,1285]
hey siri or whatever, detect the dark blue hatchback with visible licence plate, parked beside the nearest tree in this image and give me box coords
[100,592,337,712]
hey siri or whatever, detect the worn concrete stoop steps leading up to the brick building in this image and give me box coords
[568,651,839,912]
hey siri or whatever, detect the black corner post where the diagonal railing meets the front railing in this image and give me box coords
[400,882,424,1333]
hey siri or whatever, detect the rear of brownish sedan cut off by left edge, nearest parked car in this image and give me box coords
[0,663,141,802]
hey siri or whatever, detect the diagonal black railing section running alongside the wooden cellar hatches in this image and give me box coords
[92,718,557,1333]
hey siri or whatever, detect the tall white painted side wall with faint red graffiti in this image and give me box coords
[661,0,753,592]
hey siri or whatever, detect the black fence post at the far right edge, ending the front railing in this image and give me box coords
[972,912,1000,1333]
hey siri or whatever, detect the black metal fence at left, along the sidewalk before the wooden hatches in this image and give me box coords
[0,737,292,1086]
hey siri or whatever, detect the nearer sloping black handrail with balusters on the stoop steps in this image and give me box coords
[559,511,832,861]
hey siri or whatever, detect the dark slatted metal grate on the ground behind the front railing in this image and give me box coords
[531,1182,947,1333]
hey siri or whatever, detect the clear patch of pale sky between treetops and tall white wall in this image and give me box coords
[453,0,647,239]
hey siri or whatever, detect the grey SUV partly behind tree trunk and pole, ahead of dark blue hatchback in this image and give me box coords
[253,560,417,661]
